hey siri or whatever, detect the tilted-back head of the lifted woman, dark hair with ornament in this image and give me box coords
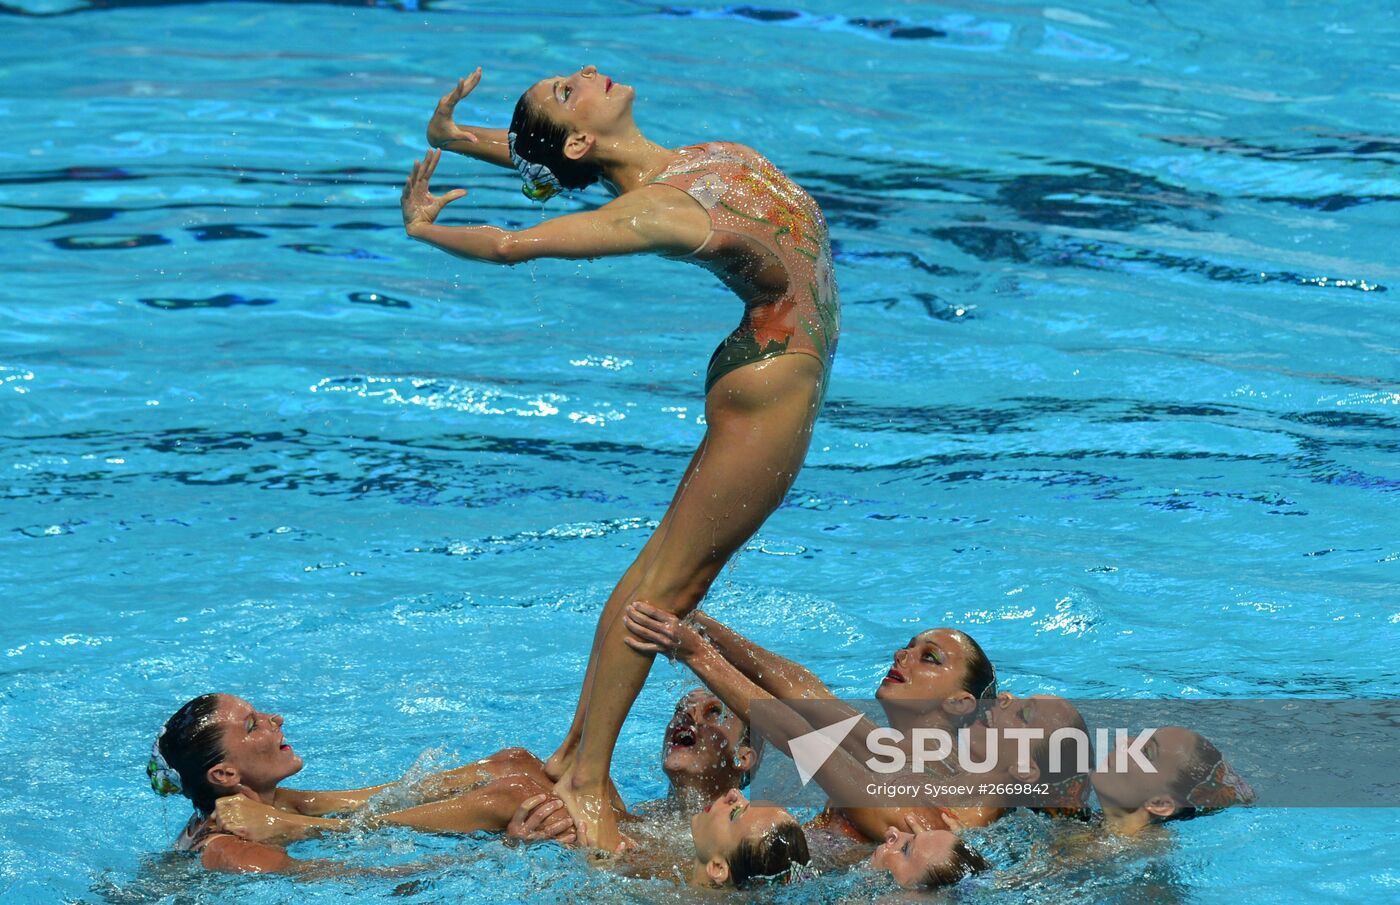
[508,66,637,202]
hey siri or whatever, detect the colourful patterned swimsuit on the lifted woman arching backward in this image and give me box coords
[652,141,841,394]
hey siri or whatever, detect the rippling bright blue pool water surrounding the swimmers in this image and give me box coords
[0,0,1400,905]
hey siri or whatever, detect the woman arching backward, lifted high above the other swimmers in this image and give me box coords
[402,66,840,849]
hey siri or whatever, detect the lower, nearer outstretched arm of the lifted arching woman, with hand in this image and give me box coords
[399,151,710,263]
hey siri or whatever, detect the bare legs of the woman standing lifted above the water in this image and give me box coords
[554,354,822,850]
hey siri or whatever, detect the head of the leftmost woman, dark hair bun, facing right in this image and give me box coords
[146,695,302,814]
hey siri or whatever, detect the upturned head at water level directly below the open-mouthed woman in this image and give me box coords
[690,789,811,887]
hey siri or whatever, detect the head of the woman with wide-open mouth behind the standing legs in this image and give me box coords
[661,689,753,789]
